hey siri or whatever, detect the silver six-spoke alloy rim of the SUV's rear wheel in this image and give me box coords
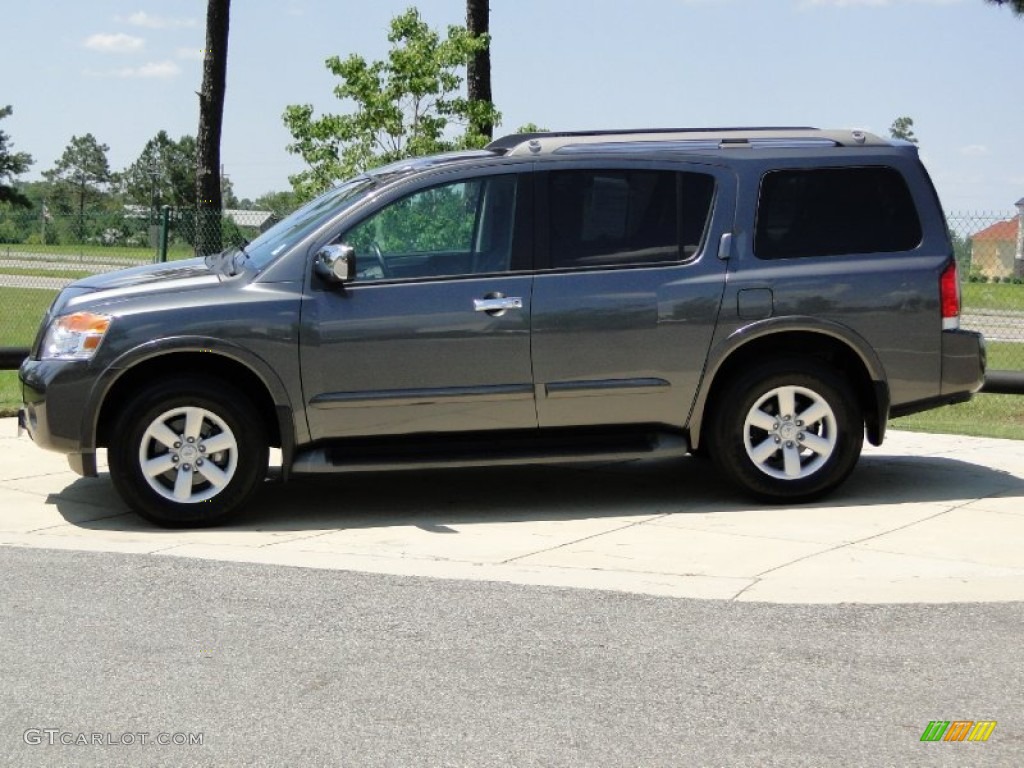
[743,386,839,480]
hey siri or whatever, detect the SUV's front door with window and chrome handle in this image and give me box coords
[301,173,537,439]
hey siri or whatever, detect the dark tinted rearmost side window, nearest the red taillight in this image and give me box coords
[754,167,922,259]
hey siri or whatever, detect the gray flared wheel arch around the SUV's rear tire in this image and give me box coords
[689,318,889,450]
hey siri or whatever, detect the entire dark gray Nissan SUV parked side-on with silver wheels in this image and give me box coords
[20,128,985,526]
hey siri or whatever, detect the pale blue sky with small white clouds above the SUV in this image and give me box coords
[0,0,1024,211]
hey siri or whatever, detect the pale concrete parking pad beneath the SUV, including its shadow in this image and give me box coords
[0,419,1024,603]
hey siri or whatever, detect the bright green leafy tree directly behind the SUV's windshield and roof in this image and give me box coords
[284,8,499,201]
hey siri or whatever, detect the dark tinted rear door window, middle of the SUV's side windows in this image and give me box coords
[548,170,715,268]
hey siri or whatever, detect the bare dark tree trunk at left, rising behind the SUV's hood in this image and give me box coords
[196,0,231,256]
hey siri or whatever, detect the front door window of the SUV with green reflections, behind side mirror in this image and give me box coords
[342,175,516,282]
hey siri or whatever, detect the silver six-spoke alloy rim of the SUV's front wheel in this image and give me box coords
[138,407,239,504]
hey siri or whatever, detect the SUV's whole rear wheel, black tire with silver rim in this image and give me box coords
[709,358,864,503]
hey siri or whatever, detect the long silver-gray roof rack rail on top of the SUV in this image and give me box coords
[486,127,891,155]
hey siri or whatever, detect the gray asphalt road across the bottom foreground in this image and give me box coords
[0,548,1024,768]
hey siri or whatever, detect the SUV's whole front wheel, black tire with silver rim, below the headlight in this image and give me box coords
[108,377,269,528]
